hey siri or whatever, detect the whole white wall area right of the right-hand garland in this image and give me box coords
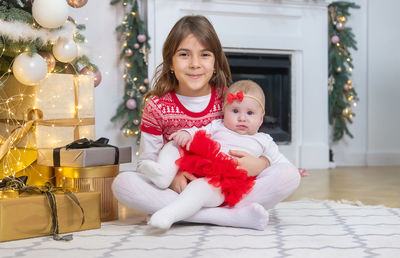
[333,0,400,166]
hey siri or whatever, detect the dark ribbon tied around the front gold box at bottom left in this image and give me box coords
[0,177,85,241]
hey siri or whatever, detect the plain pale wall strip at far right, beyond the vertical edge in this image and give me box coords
[367,0,400,165]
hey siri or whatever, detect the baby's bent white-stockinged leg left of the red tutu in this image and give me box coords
[140,141,180,189]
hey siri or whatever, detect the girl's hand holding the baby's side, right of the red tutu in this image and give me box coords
[229,150,270,176]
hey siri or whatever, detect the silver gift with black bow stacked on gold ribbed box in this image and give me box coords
[37,138,132,221]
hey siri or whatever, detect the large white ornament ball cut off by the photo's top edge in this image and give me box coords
[32,0,68,29]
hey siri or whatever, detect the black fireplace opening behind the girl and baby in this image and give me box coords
[225,52,291,143]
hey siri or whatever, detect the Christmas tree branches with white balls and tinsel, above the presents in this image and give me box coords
[0,0,101,85]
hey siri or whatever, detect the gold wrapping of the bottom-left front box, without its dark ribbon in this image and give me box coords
[0,190,100,242]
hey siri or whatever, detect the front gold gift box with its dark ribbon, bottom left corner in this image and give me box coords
[0,176,100,242]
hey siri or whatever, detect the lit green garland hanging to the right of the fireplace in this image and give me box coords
[328,1,360,142]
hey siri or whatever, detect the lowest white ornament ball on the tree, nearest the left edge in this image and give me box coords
[12,53,47,85]
